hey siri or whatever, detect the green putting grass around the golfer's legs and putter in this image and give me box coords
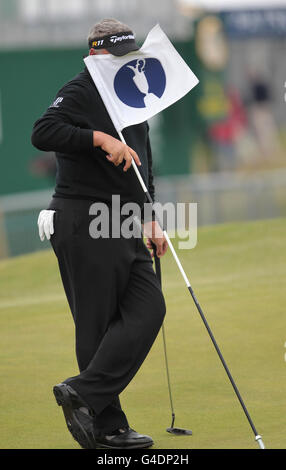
[0,219,286,449]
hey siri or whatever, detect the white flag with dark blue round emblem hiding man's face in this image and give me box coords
[84,25,199,132]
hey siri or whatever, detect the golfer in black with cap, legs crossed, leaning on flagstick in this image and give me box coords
[32,19,167,449]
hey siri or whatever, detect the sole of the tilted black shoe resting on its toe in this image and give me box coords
[53,384,96,449]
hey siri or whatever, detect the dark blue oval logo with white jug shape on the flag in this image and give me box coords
[114,58,166,108]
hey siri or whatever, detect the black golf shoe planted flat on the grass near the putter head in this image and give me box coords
[96,426,153,449]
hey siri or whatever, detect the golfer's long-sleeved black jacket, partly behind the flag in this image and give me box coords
[32,69,154,206]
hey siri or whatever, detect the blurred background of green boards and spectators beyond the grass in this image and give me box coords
[0,0,286,258]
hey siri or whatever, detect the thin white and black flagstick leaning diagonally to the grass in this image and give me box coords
[117,131,265,449]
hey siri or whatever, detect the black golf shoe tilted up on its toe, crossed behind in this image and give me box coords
[53,383,96,449]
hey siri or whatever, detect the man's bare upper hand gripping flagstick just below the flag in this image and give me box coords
[93,131,141,171]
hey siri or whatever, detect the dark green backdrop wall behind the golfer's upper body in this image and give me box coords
[0,43,199,195]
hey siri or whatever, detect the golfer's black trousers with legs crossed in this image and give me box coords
[49,198,165,433]
